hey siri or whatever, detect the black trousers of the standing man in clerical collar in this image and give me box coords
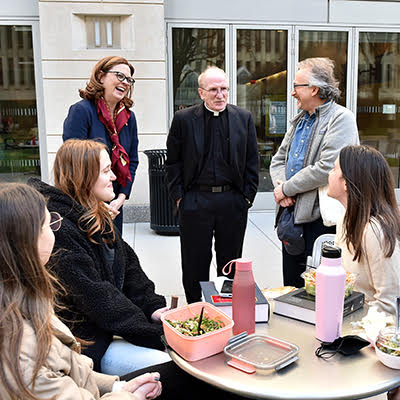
[179,191,248,303]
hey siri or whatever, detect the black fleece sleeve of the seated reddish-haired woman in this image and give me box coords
[55,223,165,347]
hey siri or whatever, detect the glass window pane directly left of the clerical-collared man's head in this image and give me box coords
[172,28,225,112]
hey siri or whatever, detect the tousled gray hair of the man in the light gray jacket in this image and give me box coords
[298,57,340,101]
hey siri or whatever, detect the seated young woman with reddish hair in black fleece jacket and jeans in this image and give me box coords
[28,139,170,376]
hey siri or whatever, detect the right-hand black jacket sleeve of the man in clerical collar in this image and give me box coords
[243,114,259,203]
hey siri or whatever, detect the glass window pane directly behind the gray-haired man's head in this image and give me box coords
[299,31,348,106]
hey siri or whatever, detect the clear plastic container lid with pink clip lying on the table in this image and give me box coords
[224,332,299,373]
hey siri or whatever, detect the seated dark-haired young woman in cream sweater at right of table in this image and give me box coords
[328,146,400,314]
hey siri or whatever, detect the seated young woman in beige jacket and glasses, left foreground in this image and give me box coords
[0,183,161,400]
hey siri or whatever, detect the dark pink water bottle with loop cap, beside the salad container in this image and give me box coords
[232,258,256,335]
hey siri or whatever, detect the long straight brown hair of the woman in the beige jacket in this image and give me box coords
[0,183,56,400]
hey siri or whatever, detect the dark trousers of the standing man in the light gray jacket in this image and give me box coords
[282,218,336,288]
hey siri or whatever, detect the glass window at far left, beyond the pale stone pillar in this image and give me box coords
[0,25,40,182]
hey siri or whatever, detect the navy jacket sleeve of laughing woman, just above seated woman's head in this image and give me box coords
[63,102,92,142]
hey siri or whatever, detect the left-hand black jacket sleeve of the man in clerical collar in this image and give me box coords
[165,112,184,202]
